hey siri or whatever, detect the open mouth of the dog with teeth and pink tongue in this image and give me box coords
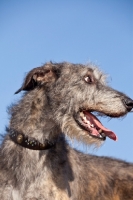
[76,110,117,141]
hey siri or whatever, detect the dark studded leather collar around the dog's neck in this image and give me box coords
[8,129,55,150]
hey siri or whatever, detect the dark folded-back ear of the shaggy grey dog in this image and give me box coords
[15,66,57,94]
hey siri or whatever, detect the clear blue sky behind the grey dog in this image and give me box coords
[0,0,133,162]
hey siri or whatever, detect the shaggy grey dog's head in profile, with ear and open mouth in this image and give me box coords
[16,63,133,143]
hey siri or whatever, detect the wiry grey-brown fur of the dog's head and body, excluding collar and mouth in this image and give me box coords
[0,63,133,200]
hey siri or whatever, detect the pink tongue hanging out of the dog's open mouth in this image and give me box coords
[84,111,117,141]
